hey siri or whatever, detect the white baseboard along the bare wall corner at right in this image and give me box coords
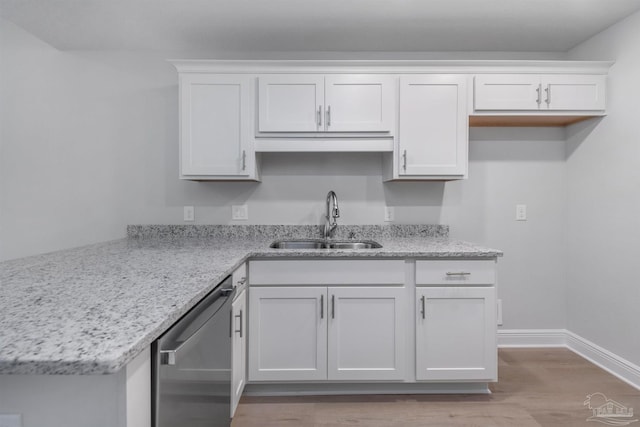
[498,329,640,390]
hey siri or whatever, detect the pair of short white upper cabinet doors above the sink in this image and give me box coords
[258,74,395,133]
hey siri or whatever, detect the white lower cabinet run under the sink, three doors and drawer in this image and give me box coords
[248,258,497,390]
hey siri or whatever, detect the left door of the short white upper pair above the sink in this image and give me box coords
[258,74,324,132]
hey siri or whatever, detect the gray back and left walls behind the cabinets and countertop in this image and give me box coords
[0,17,566,329]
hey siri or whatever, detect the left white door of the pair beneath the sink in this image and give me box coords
[249,287,327,381]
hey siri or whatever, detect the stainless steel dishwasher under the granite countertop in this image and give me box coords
[152,277,235,427]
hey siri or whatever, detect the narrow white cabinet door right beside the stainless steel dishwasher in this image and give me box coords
[231,291,247,418]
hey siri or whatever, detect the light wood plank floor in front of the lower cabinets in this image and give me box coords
[232,349,640,427]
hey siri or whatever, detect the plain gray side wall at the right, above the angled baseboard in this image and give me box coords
[567,13,640,365]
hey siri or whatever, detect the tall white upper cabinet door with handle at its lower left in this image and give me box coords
[396,75,469,177]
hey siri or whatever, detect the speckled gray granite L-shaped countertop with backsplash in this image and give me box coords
[0,226,502,374]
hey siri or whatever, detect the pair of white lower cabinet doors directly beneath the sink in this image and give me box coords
[249,286,405,381]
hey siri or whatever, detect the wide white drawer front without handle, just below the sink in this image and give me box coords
[249,260,405,286]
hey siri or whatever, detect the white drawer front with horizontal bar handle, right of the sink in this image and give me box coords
[416,260,496,286]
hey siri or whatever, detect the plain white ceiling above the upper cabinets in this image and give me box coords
[0,0,640,52]
